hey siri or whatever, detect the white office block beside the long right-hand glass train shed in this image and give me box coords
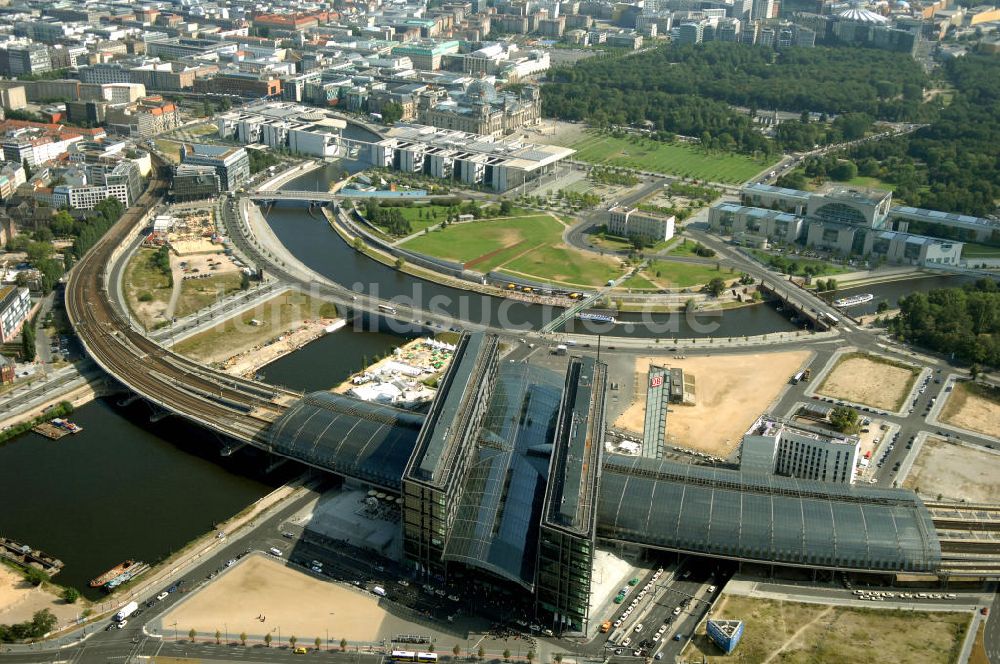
[740,417,861,484]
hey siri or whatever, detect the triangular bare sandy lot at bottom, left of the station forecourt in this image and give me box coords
[161,555,396,645]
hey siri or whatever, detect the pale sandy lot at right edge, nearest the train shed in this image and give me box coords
[903,438,1000,503]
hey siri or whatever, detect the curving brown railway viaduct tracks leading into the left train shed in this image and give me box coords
[65,159,292,446]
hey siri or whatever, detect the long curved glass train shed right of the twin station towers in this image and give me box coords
[597,457,941,572]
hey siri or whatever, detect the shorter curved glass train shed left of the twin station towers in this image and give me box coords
[268,392,424,491]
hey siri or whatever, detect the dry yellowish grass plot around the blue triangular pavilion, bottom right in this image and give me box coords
[684,596,969,664]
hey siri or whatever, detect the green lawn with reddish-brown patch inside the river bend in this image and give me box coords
[404,214,621,286]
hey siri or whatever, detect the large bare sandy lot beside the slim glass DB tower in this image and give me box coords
[615,351,810,457]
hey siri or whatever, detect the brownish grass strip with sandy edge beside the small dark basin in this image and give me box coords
[173,291,337,361]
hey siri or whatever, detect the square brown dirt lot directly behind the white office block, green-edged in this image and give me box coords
[816,353,919,411]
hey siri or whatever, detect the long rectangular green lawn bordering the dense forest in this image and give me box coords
[569,133,776,183]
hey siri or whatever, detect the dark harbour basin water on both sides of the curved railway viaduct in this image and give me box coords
[0,328,406,599]
